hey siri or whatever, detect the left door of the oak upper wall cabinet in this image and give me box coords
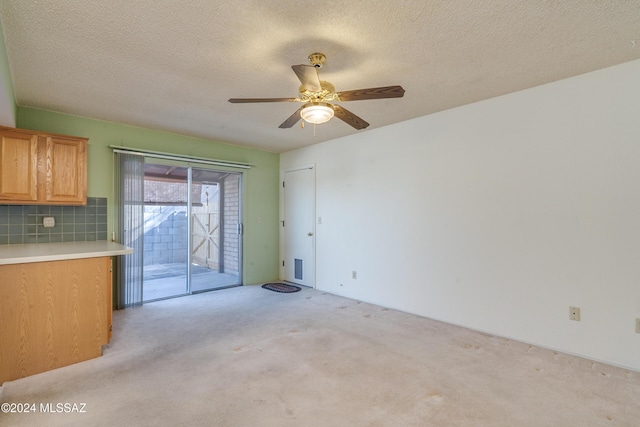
[0,131,38,201]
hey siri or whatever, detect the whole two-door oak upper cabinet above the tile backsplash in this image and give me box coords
[0,126,87,205]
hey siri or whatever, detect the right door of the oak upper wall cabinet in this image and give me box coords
[43,136,87,205]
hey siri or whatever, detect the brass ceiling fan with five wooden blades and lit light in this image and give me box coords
[229,53,404,130]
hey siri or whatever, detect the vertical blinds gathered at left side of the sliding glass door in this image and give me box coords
[116,153,144,309]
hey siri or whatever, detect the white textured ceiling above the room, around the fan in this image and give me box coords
[0,0,640,152]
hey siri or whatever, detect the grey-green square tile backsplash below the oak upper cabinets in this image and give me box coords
[0,197,107,245]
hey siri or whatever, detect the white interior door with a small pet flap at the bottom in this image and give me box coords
[283,167,316,287]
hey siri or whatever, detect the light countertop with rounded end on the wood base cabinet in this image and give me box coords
[0,240,133,265]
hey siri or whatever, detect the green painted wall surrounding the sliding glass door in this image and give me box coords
[16,107,280,284]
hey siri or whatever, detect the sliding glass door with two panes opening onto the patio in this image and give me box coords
[142,162,242,302]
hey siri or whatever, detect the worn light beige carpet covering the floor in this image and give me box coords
[0,286,640,427]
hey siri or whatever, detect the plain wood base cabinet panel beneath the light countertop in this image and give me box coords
[0,257,112,384]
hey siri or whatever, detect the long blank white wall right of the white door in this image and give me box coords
[280,61,640,370]
